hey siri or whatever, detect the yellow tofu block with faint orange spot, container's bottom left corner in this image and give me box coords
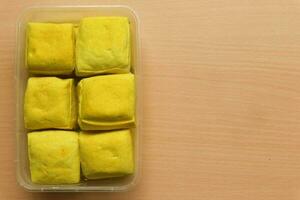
[28,130,80,185]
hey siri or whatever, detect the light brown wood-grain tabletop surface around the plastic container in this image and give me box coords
[0,0,300,200]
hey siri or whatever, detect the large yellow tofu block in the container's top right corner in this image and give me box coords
[76,17,131,76]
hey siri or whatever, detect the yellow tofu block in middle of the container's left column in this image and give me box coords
[24,77,77,130]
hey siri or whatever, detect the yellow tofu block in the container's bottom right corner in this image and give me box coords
[79,130,134,179]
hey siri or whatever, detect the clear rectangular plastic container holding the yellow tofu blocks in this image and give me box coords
[16,5,142,192]
